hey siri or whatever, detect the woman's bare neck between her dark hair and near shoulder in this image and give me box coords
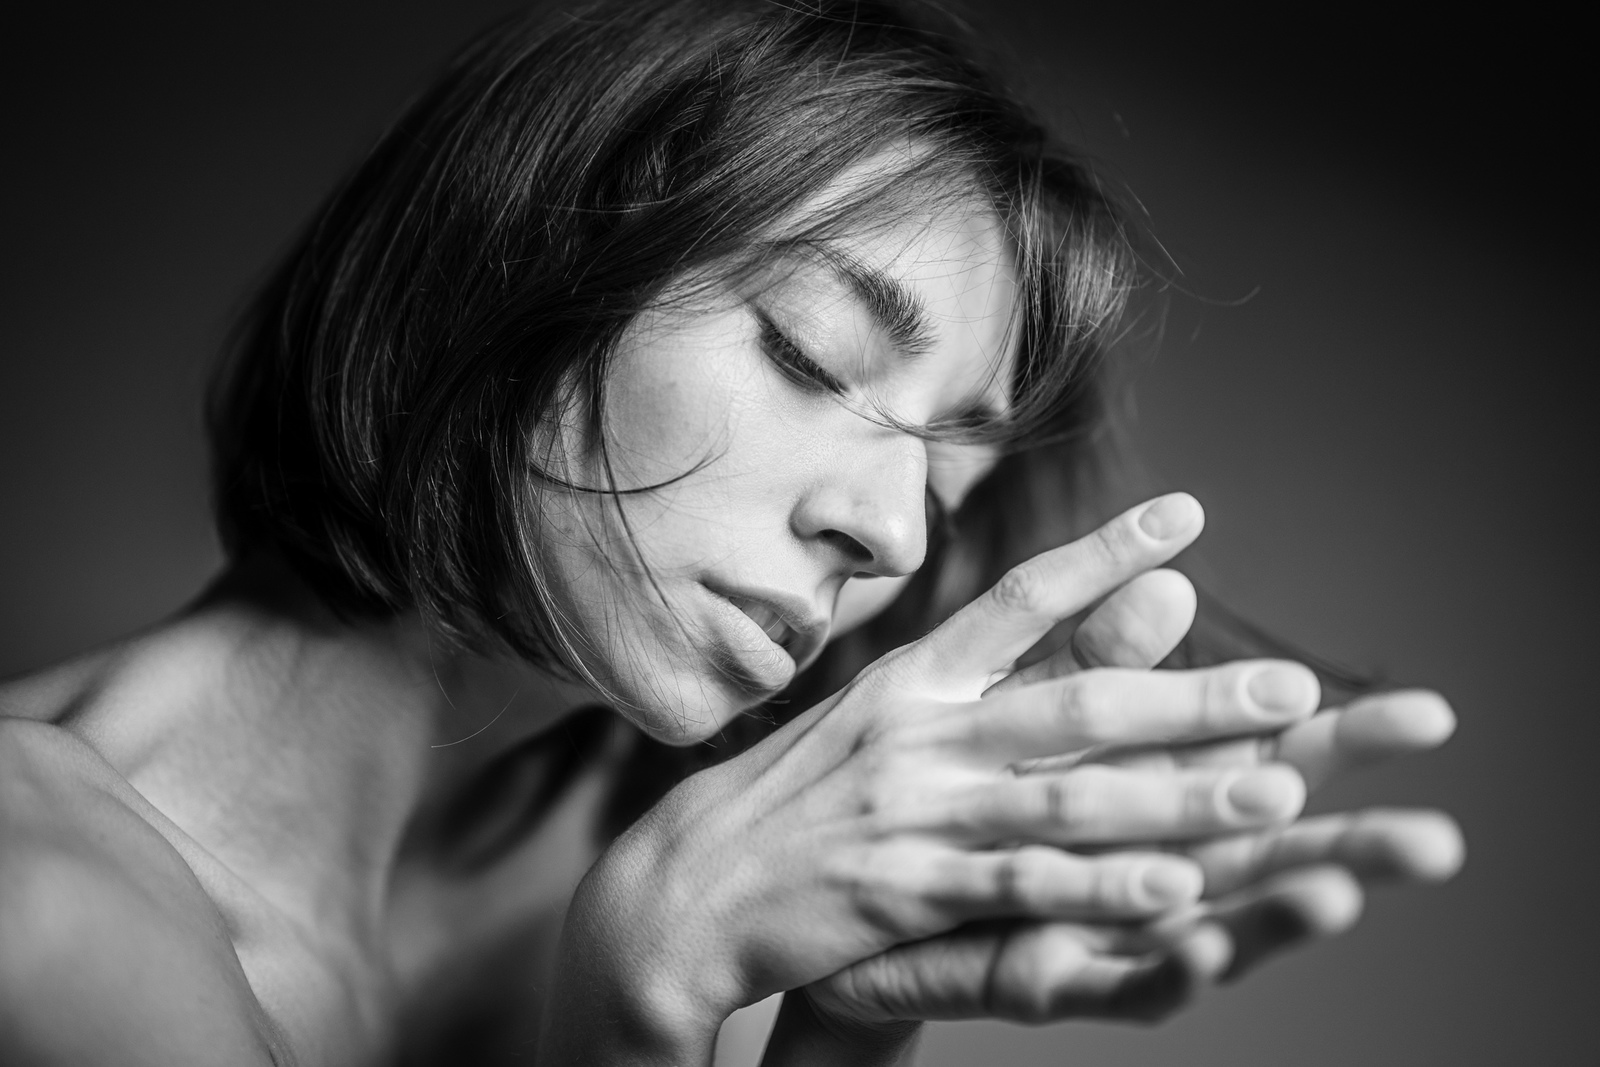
[39,560,592,936]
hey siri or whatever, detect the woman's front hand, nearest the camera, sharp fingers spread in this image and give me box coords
[541,494,1318,1062]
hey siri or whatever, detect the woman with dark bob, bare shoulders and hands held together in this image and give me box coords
[0,0,1459,1064]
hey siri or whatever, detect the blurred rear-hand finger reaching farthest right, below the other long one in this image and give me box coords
[1189,808,1466,897]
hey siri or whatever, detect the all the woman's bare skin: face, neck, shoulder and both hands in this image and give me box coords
[0,175,1459,1067]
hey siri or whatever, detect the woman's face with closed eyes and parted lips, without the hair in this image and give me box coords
[541,174,1014,744]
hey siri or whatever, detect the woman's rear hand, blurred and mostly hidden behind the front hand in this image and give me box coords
[806,571,1462,1025]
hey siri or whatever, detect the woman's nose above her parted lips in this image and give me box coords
[790,434,928,577]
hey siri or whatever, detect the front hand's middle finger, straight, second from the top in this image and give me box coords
[952,659,1320,760]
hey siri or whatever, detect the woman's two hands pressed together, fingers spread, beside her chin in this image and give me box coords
[547,494,1461,1062]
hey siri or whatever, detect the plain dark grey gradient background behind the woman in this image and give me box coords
[0,0,1600,1065]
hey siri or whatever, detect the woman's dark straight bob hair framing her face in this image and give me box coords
[208,0,1136,677]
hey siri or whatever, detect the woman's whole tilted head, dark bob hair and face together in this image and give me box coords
[211,0,1134,729]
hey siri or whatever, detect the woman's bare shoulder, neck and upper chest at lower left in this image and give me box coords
[0,569,606,1064]
